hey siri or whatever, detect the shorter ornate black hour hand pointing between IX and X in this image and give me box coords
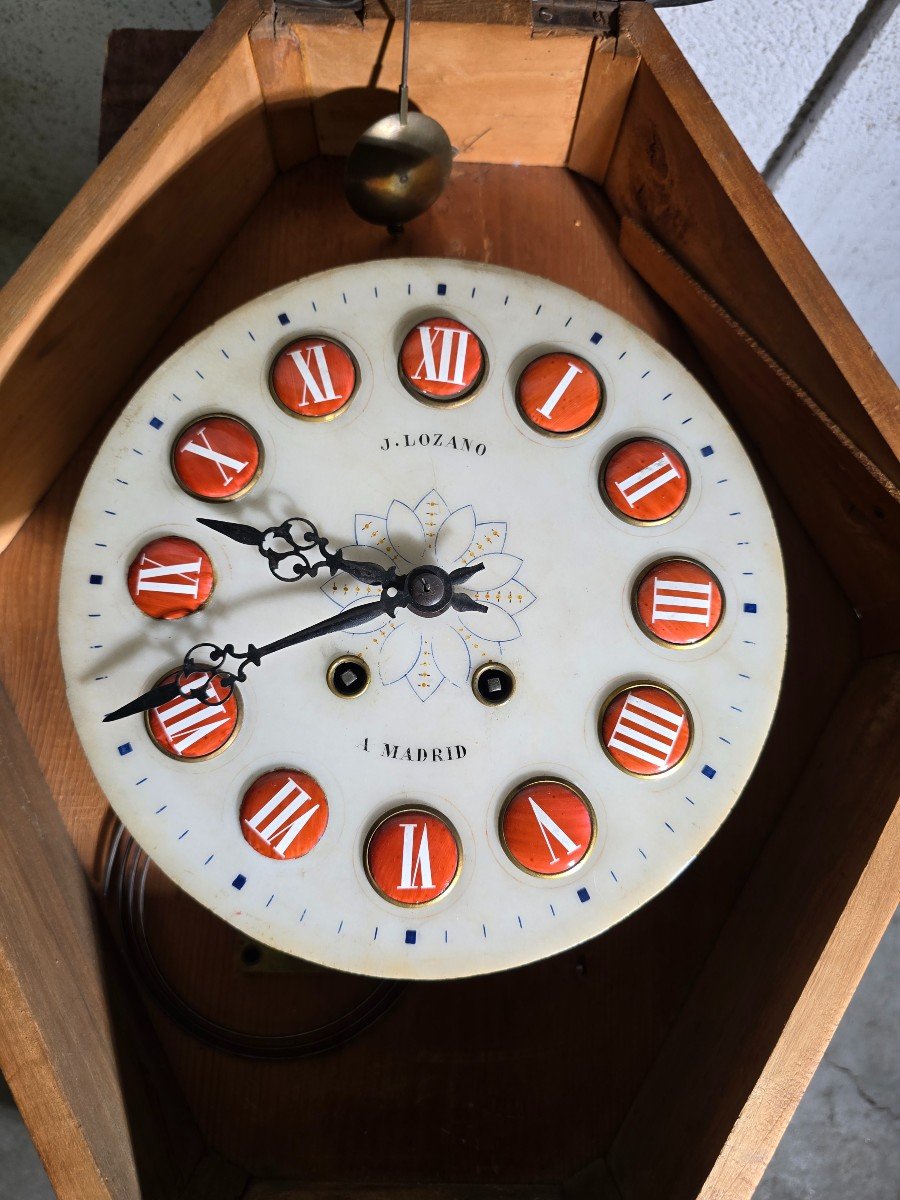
[197,517,396,587]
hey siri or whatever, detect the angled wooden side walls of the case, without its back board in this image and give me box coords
[0,0,900,1200]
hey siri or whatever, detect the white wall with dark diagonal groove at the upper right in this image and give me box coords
[660,0,900,379]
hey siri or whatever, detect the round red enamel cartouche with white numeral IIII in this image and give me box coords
[600,684,691,775]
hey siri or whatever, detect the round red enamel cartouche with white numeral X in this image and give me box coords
[172,415,263,500]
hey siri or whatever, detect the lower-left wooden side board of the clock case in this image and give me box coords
[0,686,211,1200]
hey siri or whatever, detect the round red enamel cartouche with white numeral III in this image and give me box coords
[634,558,725,646]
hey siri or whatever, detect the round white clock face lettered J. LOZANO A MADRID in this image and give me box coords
[60,259,786,979]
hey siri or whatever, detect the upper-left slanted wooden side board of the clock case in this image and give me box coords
[0,0,275,550]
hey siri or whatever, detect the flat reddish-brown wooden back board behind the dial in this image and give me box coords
[0,160,856,1186]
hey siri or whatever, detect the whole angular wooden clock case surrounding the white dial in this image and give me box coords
[0,0,900,1200]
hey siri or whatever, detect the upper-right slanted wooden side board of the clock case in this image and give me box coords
[605,0,900,484]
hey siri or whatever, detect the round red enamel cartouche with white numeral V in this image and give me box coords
[500,779,595,876]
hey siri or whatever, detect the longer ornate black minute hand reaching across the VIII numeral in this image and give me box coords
[103,590,409,721]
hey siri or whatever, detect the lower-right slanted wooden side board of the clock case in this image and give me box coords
[608,655,900,1200]
